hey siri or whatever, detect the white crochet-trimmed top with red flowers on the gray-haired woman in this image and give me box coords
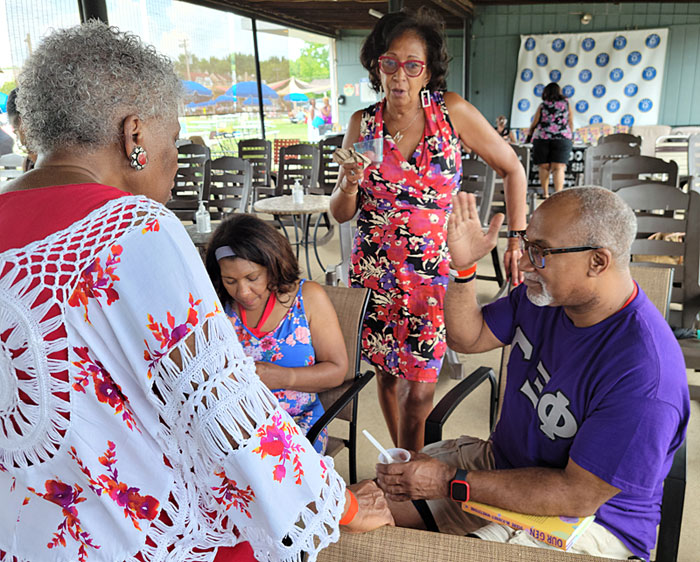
[0,185,345,562]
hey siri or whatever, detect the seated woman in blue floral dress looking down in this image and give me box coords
[206,214,348,453]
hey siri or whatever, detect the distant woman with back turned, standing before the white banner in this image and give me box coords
[528,82,574,199]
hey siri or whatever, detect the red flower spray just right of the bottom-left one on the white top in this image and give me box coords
[69,441,160,531]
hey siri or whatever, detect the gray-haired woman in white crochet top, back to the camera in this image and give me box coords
[0,18,392,562]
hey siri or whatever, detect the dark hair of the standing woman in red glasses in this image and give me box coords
[360,8,450,92]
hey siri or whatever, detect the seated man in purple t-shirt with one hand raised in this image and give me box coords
[377,188,689,558]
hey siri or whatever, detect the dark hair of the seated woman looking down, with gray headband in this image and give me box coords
[205,213,301,304]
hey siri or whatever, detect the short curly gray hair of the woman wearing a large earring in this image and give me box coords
[17,20,182,152]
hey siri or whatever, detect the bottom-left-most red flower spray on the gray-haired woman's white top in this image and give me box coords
[24,480,100,562]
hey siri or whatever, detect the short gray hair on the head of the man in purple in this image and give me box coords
[548,186,637,266]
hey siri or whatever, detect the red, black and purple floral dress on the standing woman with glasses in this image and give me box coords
[350,92,462,382]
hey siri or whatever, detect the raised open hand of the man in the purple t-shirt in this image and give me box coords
[447,192,505,269]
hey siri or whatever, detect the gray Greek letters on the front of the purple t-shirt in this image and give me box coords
[512,326,578,441]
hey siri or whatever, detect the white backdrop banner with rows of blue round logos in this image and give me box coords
[511,29,668,128]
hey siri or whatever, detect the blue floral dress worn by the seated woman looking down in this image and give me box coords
[226,279,328,453]
